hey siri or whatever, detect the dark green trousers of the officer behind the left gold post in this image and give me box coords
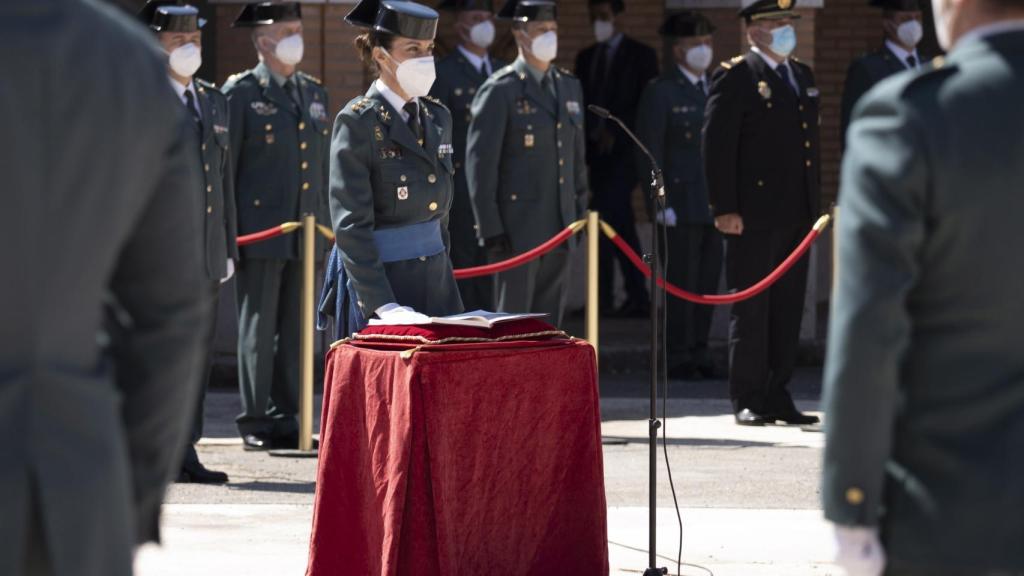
[236,258,302,437]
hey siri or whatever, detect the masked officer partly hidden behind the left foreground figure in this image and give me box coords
[139,0,239,484]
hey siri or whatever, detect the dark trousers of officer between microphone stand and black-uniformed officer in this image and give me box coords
[665,223,723,368]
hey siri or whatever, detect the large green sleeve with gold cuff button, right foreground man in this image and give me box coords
[822,84,930,526]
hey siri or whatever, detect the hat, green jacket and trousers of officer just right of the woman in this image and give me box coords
[466,0,587,324]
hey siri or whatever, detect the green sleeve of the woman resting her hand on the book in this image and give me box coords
[331,114,395,318]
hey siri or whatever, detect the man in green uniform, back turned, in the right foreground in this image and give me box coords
[822,0,1024,576]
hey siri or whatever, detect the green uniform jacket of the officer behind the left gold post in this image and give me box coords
[224,64,331,259]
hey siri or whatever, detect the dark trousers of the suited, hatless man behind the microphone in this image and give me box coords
[589,159,647,310]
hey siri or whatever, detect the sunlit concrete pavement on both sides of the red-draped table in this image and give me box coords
[137,370,841,576]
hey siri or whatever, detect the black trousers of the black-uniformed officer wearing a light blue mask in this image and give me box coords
[725,227,808,414]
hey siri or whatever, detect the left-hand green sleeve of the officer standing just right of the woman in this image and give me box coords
[466,82,509,239]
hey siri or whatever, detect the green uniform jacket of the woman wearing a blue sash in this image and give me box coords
[331,83,462,318]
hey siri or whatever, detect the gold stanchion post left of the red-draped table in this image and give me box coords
[299,214,316,452]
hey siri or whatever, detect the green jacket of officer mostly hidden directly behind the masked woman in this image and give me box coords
[430,48,505,254]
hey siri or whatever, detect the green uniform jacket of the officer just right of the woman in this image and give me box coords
[466,58,588,252]
